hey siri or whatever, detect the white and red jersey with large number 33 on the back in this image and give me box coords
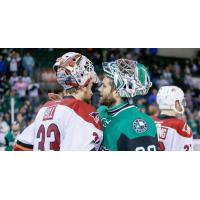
[15,97,103,151]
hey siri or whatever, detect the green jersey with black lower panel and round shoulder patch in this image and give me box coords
[98,102,157,151]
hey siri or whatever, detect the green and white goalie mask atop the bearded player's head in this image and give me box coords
[103,59,152,98]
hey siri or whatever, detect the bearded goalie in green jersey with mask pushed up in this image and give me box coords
[98,59,157,151]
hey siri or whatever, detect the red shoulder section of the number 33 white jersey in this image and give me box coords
[43,98,102,130]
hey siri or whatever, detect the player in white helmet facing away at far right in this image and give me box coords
[154,86,193,151]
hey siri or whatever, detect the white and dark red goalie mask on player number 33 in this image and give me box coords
[53,52,98,90]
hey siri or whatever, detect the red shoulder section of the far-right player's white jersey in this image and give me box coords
[154,117,192,138]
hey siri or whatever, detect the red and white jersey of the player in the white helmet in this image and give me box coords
[153,115,193,151]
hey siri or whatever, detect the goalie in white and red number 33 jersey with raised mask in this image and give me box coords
[15,52,103,151]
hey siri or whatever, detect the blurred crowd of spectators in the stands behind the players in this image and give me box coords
[0,48,200,150]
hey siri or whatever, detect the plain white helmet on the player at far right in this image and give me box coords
[156,86,186,114]
